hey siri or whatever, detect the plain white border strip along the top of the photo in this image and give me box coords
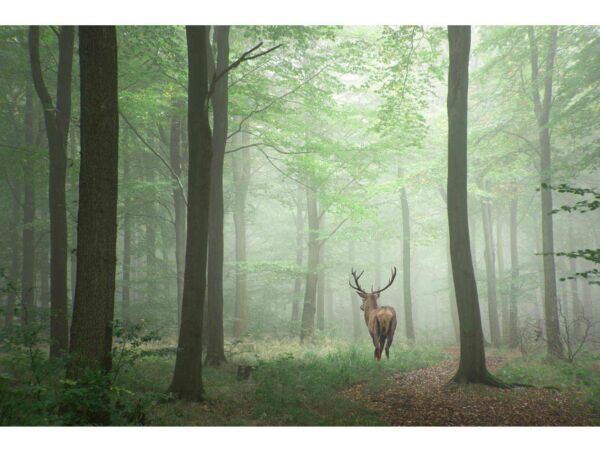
[0,0,600,25]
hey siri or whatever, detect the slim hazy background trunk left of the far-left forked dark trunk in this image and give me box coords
[20,84,35,326]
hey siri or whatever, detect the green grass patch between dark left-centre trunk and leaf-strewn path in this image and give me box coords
[122,340,447,426]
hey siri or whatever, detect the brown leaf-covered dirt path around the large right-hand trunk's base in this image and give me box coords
[347,357,591,426]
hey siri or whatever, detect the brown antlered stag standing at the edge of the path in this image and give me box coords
[348,267,397,361]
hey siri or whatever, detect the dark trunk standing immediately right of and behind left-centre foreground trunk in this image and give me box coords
[206,26,229,366]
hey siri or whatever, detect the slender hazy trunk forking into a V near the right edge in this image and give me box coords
[528,27,563,358]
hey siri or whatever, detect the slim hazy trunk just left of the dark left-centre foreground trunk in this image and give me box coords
[169,99,186,330]
